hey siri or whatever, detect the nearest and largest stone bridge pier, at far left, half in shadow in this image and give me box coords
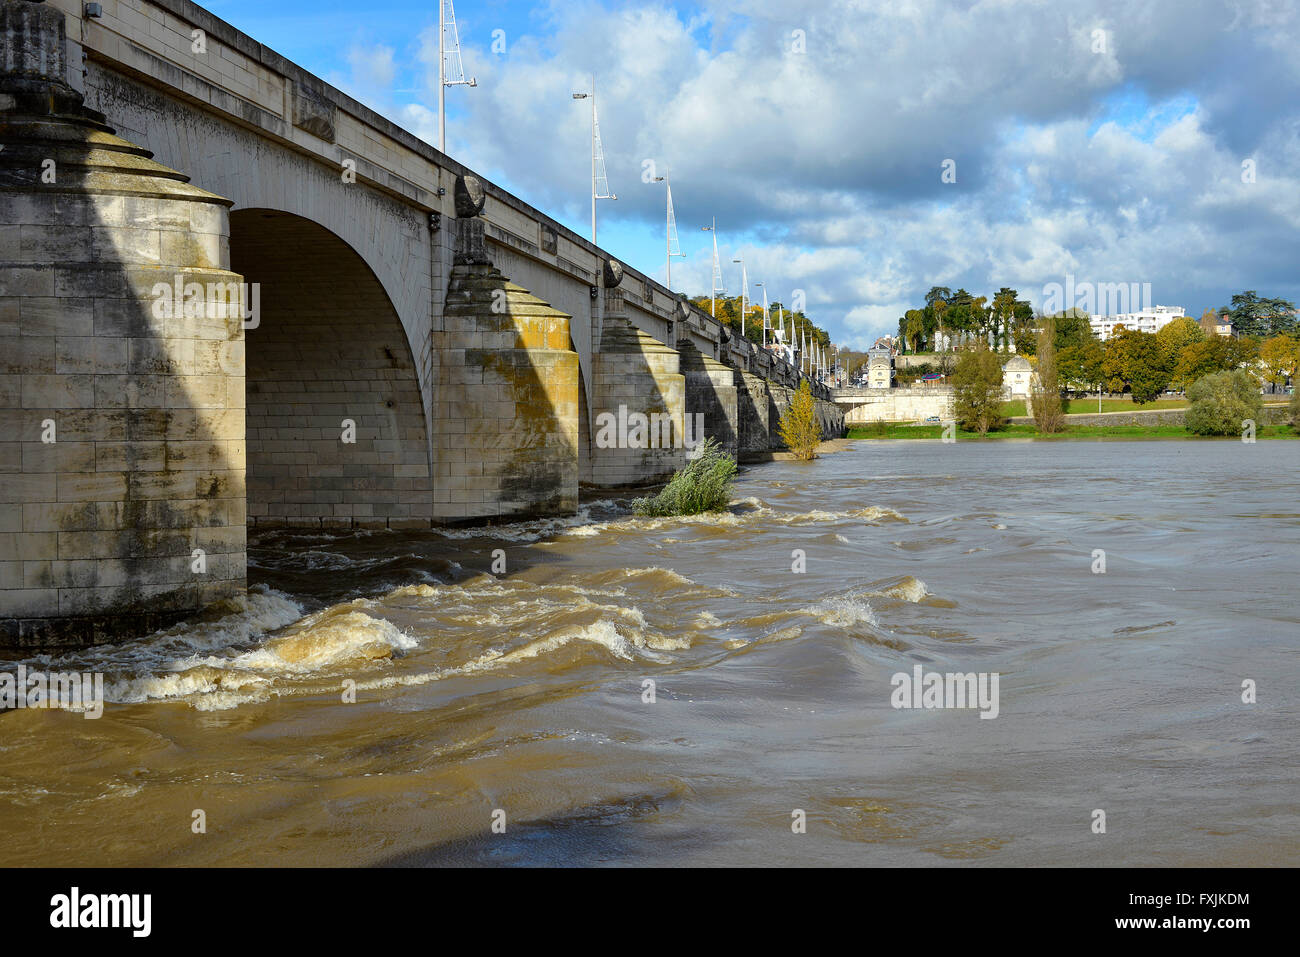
[0,0,244,646]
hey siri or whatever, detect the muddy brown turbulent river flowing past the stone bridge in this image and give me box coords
[0,442,1300,865]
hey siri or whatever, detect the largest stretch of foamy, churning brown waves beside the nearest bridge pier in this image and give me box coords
[55,566,717,711]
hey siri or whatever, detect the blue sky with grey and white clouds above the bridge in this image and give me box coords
[200,0,1300,346]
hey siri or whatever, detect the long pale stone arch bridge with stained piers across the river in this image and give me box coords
[0,0,844,646]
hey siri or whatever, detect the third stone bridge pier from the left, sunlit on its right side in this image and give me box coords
[590,287,686,488]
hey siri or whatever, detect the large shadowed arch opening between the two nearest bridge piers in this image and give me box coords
[230,207,433,528]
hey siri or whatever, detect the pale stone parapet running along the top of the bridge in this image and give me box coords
[51,0,790,379]
